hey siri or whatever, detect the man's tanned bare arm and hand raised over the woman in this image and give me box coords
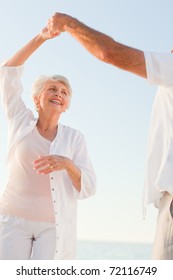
[51,13,146,78]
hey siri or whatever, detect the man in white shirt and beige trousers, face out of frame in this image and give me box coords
[47,13,173,259]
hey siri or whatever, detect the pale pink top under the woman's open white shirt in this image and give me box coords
[0,126,55,223]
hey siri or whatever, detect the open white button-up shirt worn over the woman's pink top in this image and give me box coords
[0,66,96,260]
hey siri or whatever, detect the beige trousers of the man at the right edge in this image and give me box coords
[152,192,173,260]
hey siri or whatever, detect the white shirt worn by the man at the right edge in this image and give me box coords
[143,52,173,215]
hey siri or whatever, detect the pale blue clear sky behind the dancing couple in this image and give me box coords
[0,0,173,242]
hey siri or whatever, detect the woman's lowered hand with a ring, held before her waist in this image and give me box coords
[33,155,70,174]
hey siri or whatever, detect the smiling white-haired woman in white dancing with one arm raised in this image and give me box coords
[0,25,95,260]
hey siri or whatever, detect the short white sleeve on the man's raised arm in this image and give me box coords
[144,52,173,87]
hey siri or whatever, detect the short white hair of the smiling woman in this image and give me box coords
[32,75,72,97]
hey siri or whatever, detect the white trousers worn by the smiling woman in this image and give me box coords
[0,215,56,260]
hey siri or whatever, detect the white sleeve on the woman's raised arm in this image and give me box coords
[0,65,26,119]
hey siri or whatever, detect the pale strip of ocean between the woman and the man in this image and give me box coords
[77,240,152,260]
